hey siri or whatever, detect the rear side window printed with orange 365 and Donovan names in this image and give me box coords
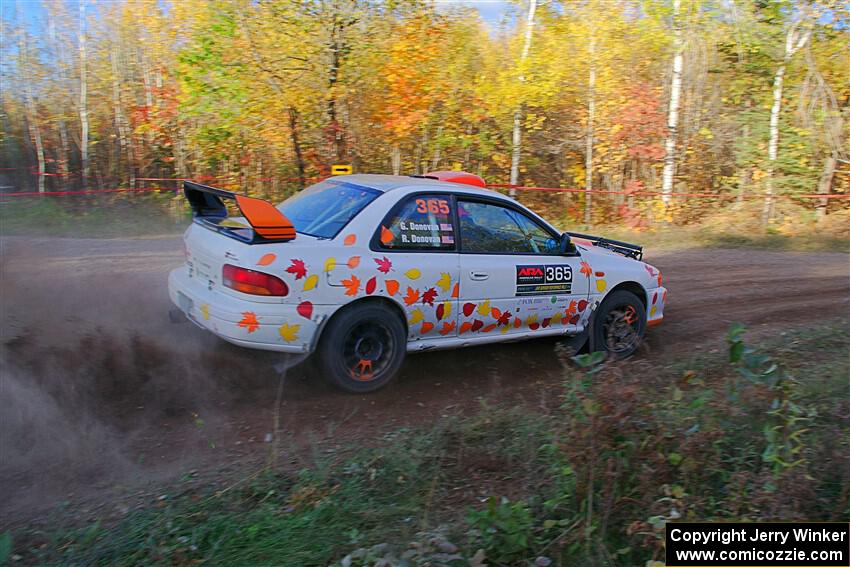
[379,195,455,250]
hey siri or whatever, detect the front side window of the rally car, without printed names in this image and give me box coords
[457,201,558,254]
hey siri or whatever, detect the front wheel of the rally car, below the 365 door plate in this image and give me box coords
[593,289,646,360]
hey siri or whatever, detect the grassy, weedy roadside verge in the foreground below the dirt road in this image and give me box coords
[8,322,850,566]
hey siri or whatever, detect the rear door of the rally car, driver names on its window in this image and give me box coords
[372,192,460,341]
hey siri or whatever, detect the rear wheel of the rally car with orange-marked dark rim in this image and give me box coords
[316,303,407,394]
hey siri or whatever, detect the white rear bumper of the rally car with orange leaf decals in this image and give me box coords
[168,267,330,353]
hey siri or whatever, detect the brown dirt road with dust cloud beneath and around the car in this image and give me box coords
[0,237,850,528]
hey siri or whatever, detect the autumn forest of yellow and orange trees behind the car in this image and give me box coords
[0,0,850,234]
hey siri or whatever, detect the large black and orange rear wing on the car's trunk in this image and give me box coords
[183,181,295,244]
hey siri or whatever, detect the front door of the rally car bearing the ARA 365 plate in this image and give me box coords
[457,197,589,335]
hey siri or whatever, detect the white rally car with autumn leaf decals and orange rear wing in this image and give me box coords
[168,172,667,392]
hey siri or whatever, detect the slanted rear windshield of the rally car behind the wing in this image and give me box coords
[277,179,380,238]
